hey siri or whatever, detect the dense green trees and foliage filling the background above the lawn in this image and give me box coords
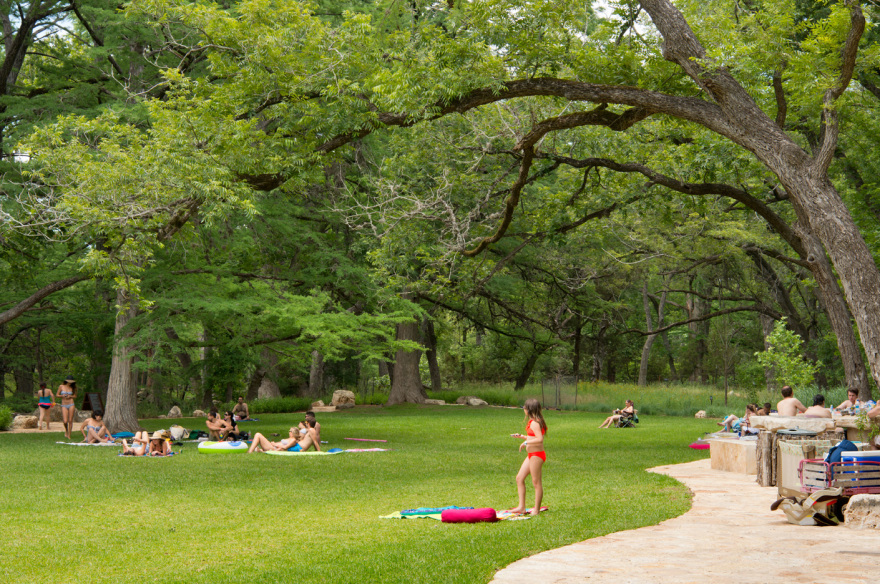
[0,0,880,428]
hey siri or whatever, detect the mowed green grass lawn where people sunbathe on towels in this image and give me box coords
[0,406,717,584]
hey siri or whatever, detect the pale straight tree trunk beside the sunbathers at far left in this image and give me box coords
[104,288,140,432]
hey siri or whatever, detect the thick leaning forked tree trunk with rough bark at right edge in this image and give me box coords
[640,0,880,394]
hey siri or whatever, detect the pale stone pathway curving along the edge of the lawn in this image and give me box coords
[492,459,880,584]
